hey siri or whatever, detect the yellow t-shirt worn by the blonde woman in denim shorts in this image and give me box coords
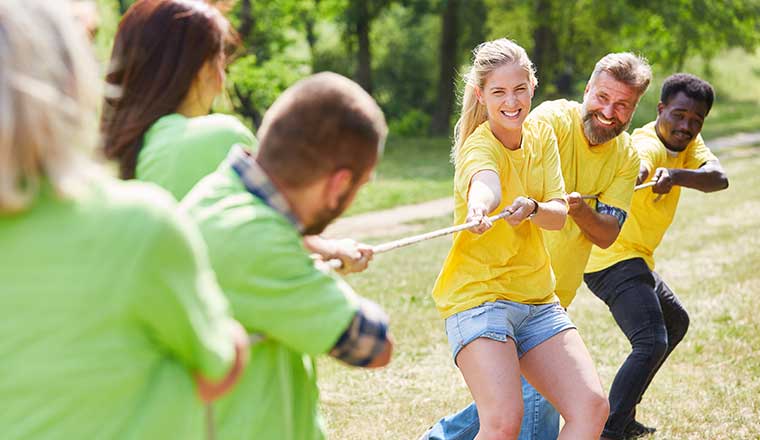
[433,120,565,318]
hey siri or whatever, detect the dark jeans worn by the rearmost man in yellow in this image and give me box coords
[583,258,689,439]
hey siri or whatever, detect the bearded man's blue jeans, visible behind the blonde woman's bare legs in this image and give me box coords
[427,378,559,440]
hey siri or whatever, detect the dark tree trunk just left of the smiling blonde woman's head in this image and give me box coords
[430,0,460,135]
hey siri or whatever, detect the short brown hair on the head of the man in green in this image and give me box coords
[257,72,388,189]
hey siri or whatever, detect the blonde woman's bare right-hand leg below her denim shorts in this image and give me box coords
[520,329,609,440]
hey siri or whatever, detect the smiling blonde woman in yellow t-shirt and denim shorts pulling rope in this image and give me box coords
[433,39,609,440]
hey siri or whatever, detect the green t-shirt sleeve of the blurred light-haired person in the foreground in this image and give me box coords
[134,205,235,379]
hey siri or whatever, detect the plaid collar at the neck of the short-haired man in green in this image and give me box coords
[227,144,304,233]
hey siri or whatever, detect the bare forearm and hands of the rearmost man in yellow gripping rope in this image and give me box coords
[639,160,728,194]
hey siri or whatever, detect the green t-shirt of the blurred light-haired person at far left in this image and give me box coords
[0,177,235,439]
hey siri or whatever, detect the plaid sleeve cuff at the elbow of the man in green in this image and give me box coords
[330,298,388,367]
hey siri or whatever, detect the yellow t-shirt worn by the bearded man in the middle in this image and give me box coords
[528,99,639,307]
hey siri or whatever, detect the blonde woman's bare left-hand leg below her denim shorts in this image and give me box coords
[456,338,523,440]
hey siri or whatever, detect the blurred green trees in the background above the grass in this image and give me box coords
[99,0,760,136]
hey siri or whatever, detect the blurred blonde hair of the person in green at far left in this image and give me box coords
[0,0,99,213]
